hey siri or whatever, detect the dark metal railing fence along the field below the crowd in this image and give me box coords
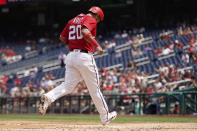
[0,89,197,115]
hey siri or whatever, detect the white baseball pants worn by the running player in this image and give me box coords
[45,49,108,120]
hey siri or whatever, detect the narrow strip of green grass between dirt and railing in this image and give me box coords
[0,114,197,123]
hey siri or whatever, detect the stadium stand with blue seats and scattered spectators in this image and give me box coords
[0,26,197,96]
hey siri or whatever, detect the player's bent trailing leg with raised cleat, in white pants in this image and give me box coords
[39,65,82,115]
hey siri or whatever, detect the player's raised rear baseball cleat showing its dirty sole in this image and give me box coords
[39,95,51,116]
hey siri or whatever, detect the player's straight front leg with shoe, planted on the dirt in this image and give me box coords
[76,56,117,124]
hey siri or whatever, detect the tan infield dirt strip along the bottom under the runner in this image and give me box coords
[0,120,197,131]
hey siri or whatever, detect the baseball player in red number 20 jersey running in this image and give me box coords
[39,6,117,125]
